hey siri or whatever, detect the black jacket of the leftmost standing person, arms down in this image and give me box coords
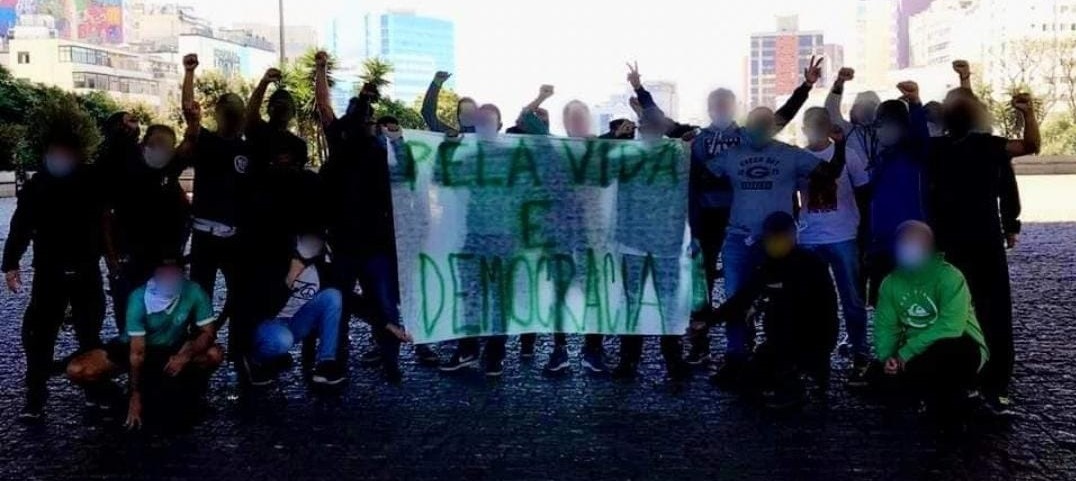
[3,166,105,272]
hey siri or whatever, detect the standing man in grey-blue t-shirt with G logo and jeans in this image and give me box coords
[707,108,847,385]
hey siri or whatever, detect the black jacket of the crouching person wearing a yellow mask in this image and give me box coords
[716,247,838,353]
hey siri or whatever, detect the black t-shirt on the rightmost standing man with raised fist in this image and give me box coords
[928,133,1020,250]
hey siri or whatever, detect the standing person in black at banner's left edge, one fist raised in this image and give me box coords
[315,55,430,382]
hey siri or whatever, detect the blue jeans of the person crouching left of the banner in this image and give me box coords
[254,288,343,363]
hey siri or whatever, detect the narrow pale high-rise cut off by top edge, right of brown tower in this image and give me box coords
[846,0,900,88]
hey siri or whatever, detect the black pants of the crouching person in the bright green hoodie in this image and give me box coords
[875,336,982,406]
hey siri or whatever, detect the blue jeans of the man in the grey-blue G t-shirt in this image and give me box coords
[721,234,764,358]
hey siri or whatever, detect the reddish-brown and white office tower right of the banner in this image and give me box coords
[747,16,825,108]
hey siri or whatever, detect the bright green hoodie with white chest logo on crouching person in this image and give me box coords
[874,255,990,368]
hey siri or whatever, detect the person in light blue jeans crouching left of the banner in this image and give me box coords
[249,232,365,385]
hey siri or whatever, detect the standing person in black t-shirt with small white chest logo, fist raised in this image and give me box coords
[175,54,252,352]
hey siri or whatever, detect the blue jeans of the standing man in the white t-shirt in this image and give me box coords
[804,240,870,355]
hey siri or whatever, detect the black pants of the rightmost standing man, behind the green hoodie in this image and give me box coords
[946,245,1016,396]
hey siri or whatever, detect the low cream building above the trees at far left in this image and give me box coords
[4,26,164,109]
